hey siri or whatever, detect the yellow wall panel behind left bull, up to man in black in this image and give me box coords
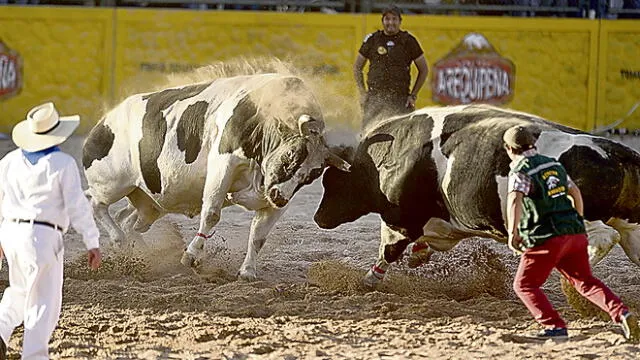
[115,9,363,128]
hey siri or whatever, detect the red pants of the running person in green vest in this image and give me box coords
[513,234,627,328]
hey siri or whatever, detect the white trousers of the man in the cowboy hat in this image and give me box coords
[0,221,64,360]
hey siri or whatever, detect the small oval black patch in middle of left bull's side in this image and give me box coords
[176,101,209,164]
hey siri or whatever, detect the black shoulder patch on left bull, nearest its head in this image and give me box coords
[218,96,262,159]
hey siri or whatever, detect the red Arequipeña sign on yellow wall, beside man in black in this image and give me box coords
[431,33,515,105]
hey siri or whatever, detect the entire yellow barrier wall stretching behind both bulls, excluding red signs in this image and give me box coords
[0,6,640,132]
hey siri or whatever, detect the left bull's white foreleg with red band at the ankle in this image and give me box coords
[180,154,237,267]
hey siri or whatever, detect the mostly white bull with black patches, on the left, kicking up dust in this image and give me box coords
[82,74,349,279]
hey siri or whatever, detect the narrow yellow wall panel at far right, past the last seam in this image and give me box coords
[596,20,640,129]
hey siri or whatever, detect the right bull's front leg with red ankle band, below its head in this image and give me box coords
[362,221,410,288]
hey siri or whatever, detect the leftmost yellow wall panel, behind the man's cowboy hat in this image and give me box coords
[0,6,113,133]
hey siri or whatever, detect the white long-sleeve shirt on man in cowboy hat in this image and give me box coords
[0,149,100,250]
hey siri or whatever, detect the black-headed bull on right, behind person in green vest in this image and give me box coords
[315,105,640,286]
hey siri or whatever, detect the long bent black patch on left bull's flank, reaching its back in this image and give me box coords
[138,83,211,194]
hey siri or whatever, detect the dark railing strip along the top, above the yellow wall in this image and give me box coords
[0,0,640,18]
